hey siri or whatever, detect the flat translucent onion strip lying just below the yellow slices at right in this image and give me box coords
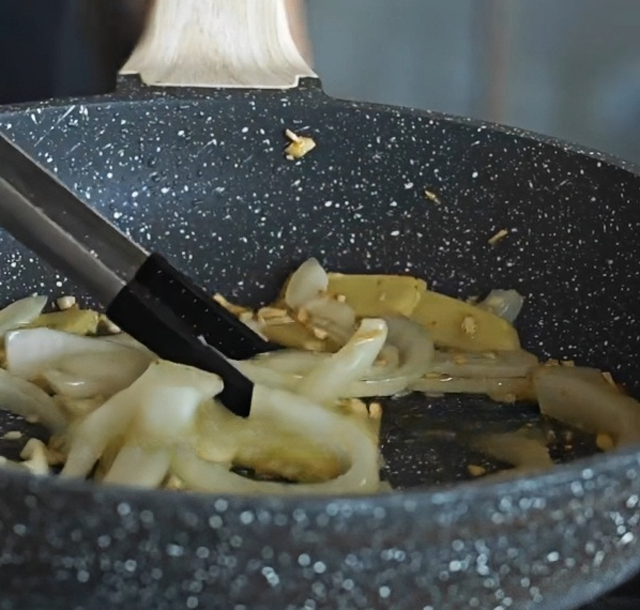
[429,350,538,379]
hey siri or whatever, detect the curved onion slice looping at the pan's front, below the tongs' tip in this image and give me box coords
[171,386,379,494]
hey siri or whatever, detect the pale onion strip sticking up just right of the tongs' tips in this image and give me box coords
[295,318,387,404]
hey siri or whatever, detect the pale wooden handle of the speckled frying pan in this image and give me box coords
[121,0,316,89]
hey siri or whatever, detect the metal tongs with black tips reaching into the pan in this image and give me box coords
[0,135,277,417]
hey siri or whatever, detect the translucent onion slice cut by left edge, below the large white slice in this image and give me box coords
[0,368,67,434]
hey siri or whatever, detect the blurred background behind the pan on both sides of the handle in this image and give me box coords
[0,0,640,163]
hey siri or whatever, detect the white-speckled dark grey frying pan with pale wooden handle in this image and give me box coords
[0,0,640,610]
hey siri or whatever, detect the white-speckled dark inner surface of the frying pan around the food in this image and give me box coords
[0,80,640,487]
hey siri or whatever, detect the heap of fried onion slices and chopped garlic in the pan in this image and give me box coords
[0,259,640,494]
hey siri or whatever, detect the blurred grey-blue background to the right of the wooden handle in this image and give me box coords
[307,0,640,162]
